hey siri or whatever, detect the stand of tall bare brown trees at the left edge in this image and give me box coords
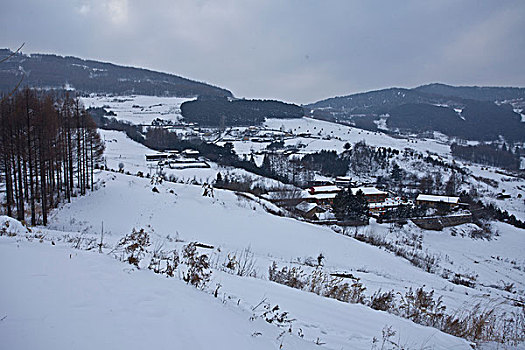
[0,89,104,225]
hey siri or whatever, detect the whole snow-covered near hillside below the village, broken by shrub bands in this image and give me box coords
[0,163,524,349]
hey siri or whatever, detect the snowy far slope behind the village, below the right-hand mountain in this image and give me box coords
[266,118,525,220]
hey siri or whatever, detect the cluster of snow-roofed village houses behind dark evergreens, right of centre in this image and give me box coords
[294,177,460,221]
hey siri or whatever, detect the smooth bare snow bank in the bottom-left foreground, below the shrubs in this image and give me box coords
[0,239,317,350]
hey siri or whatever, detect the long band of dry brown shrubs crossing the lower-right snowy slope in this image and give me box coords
[268,262,525,349]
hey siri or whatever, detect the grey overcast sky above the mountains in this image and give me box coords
[0,0,525,103]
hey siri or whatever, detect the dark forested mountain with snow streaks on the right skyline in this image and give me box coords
[305,84,525,142]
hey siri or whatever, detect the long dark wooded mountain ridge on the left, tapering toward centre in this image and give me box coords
[0,49,232,97]
